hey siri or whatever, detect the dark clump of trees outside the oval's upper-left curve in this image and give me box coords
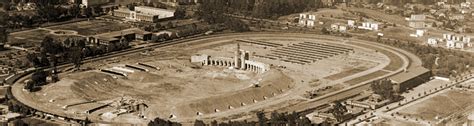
[25,36,129,91]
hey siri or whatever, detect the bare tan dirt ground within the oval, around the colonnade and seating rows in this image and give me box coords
[21,36,390,122]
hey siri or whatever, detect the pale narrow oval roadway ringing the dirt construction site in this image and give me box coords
[7,33,417,121]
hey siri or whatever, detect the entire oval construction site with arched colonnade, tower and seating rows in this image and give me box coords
[12,33,412,124]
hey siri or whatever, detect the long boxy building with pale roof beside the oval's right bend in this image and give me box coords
[390,66,432,93]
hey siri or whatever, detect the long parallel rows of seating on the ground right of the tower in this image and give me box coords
[262,40,354,65]
